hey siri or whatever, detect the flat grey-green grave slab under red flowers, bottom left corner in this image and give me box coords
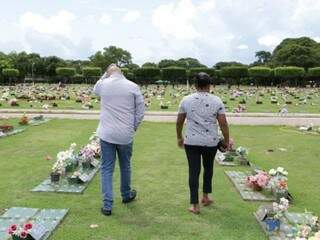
[0,207,69,240]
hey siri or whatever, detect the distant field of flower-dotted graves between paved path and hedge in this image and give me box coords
[0,84,320,113]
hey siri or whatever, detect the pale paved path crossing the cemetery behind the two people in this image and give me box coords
[0,109,320,126]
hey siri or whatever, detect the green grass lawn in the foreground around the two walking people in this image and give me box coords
[0,120,320,240]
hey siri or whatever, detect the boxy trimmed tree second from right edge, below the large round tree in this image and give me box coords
[274,67,305,86]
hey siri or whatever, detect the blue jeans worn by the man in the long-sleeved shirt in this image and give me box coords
[100,140,132,210]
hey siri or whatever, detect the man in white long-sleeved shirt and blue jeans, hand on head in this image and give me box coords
[93,64,144,216]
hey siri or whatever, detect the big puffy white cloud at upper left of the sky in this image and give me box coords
[19,10,76,36]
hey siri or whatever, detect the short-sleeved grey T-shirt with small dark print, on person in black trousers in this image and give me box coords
[179,92,225,147]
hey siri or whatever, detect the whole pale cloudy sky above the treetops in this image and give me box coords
[0,0,320,66]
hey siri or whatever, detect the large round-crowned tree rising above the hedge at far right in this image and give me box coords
[271,37,320,69]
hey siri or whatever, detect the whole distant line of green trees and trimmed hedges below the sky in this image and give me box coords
[0,37,320,86]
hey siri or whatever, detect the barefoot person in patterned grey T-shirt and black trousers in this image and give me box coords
[177,73,229,214]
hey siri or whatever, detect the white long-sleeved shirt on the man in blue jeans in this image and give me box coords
[93,73,144,145]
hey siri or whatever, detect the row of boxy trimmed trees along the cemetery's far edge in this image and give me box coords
[0,64,320,87]
